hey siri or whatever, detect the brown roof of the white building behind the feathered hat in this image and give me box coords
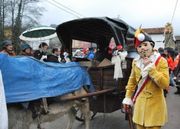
[143,27,164,34]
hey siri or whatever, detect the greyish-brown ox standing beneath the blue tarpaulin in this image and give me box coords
[8,88,90,129]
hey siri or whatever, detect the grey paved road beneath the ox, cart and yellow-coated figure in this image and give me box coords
[31,88,180,129]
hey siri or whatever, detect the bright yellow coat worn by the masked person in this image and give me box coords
[126,57,169,127]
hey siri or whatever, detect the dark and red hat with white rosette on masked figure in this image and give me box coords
[134,27,155,48]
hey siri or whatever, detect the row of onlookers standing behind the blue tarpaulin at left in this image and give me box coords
[1,40,70,63]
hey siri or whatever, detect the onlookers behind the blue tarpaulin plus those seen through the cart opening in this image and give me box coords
[1,40,103,63]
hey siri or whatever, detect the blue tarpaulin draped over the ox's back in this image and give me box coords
[0,54,93,103]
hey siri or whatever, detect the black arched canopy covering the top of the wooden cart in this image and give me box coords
[56,17,135,50]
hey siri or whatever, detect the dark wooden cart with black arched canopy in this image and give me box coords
[56,17,136,120]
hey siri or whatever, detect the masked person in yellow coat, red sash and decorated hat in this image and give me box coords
[122,29,169,129]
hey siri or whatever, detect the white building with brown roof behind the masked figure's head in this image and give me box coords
[143,27,164,49]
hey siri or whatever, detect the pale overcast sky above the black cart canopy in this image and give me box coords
[40,0,180,35]
